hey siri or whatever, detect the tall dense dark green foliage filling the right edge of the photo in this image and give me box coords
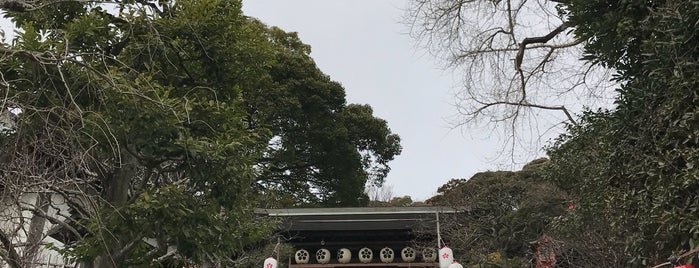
[548,1,699,266]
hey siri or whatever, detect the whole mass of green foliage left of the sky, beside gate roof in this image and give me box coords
[0,0,401,267]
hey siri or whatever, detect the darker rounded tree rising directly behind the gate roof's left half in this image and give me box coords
[249,27,401,206]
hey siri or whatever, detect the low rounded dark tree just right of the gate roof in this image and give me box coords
[426,159,567,265]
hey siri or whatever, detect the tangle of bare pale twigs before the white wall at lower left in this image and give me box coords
[0,98,98,268]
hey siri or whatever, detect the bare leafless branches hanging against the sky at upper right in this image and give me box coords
[406,0,612,160]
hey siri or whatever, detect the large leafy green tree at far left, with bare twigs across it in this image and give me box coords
[0,1,272,267]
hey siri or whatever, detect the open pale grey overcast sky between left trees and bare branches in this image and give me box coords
[243,0,533,200]
